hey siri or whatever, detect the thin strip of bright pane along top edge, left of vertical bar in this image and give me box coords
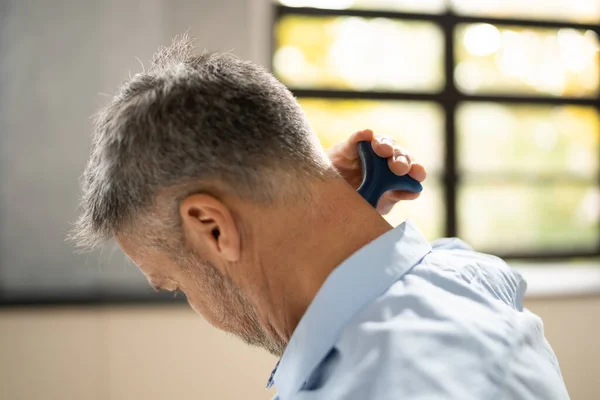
[279,0,446,13]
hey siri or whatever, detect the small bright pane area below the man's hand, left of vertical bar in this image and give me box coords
[385,178,444,241]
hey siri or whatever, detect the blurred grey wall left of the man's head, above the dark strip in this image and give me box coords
[0,0,271,296]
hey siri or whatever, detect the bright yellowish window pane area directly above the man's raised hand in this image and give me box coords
[298,98,444,173]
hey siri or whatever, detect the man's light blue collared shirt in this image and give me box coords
[268,221,569,400]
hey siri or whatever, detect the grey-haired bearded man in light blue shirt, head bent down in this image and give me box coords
[73,39,568,400]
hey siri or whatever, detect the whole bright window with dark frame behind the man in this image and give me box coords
[273,0,600,260]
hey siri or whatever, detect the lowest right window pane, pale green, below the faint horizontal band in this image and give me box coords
[458,184,600,252]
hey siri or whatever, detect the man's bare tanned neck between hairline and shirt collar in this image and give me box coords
[258,182,392,343]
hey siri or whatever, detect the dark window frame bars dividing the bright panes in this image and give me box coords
[270,4,600,262]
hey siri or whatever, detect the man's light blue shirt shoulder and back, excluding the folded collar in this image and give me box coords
[299,246,565,400]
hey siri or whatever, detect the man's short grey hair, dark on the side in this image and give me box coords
[71,36,336,249]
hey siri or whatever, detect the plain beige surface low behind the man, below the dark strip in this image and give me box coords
[0,297,600,400]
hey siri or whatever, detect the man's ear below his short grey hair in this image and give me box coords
[179,194,240,262]
